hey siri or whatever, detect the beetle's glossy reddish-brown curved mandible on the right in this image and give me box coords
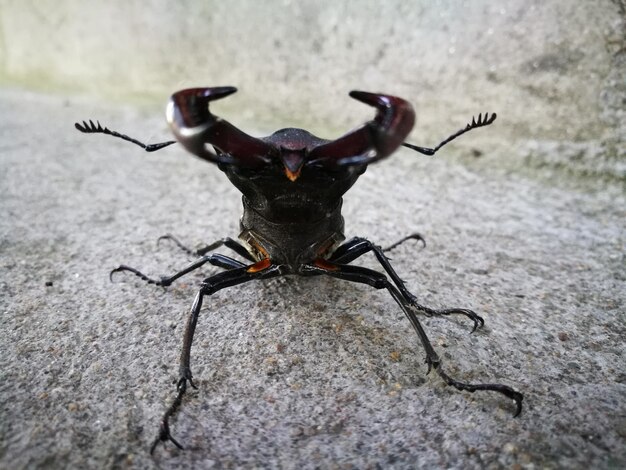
[310,91,415,167]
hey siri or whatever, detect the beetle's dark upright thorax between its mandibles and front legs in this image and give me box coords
[220,129,365,269]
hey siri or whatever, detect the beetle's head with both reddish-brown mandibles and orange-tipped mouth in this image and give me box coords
[167,87,415,181]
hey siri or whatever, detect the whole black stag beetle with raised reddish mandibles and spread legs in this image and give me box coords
[75,87,523,453]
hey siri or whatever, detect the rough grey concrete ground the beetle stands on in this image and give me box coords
[0,89,626,469]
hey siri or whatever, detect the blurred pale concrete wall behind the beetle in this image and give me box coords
[0,0,626,182]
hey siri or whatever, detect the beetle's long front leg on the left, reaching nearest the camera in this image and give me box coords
[150,260,284,454]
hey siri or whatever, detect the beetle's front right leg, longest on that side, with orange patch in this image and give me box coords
[302,261,524,417]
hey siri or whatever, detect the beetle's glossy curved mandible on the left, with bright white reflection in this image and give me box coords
[166,87,276,168]
